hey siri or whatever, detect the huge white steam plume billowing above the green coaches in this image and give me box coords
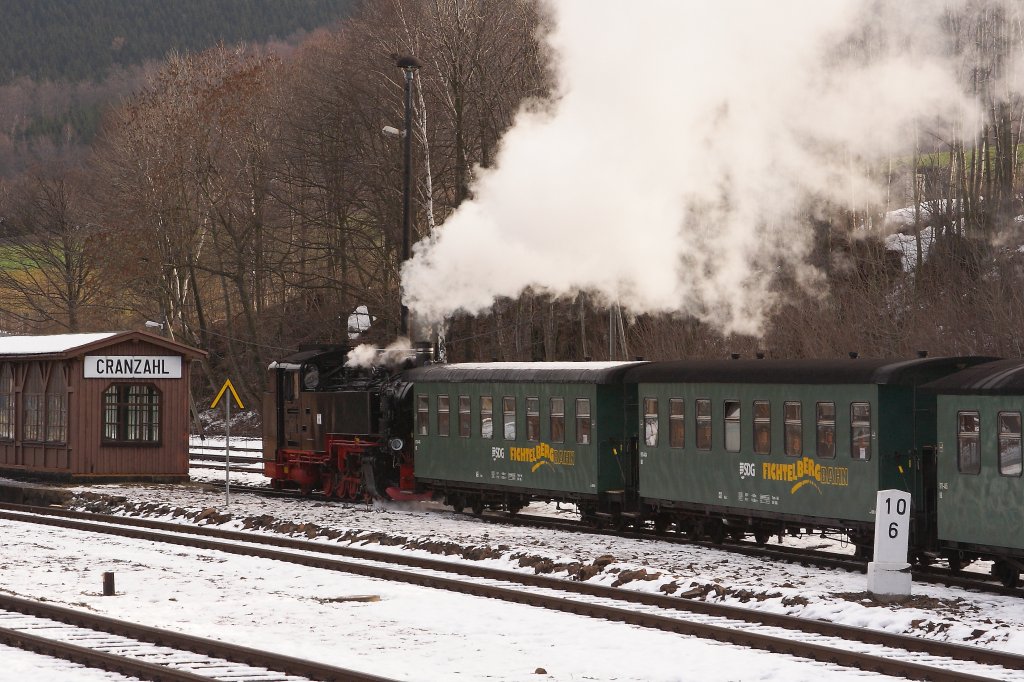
[402,0,991,333]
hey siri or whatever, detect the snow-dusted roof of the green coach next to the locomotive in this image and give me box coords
[406,363,644,384]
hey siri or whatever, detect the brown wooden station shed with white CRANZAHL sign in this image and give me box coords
[0,332,206,481]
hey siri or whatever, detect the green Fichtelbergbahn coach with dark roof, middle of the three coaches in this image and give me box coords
[626,357,972,553]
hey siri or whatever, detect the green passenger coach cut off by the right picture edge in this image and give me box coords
[926,359,1024,587]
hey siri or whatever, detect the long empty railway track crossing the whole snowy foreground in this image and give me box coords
[0,505,1024,681]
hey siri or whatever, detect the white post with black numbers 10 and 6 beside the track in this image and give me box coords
[867,491,910,598]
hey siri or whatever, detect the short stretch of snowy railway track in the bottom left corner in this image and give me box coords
[0,595,393,682]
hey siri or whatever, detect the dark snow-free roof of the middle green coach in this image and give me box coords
[625,357,988,384]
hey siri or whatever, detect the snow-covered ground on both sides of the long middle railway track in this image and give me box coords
[0,441,1024,681]
